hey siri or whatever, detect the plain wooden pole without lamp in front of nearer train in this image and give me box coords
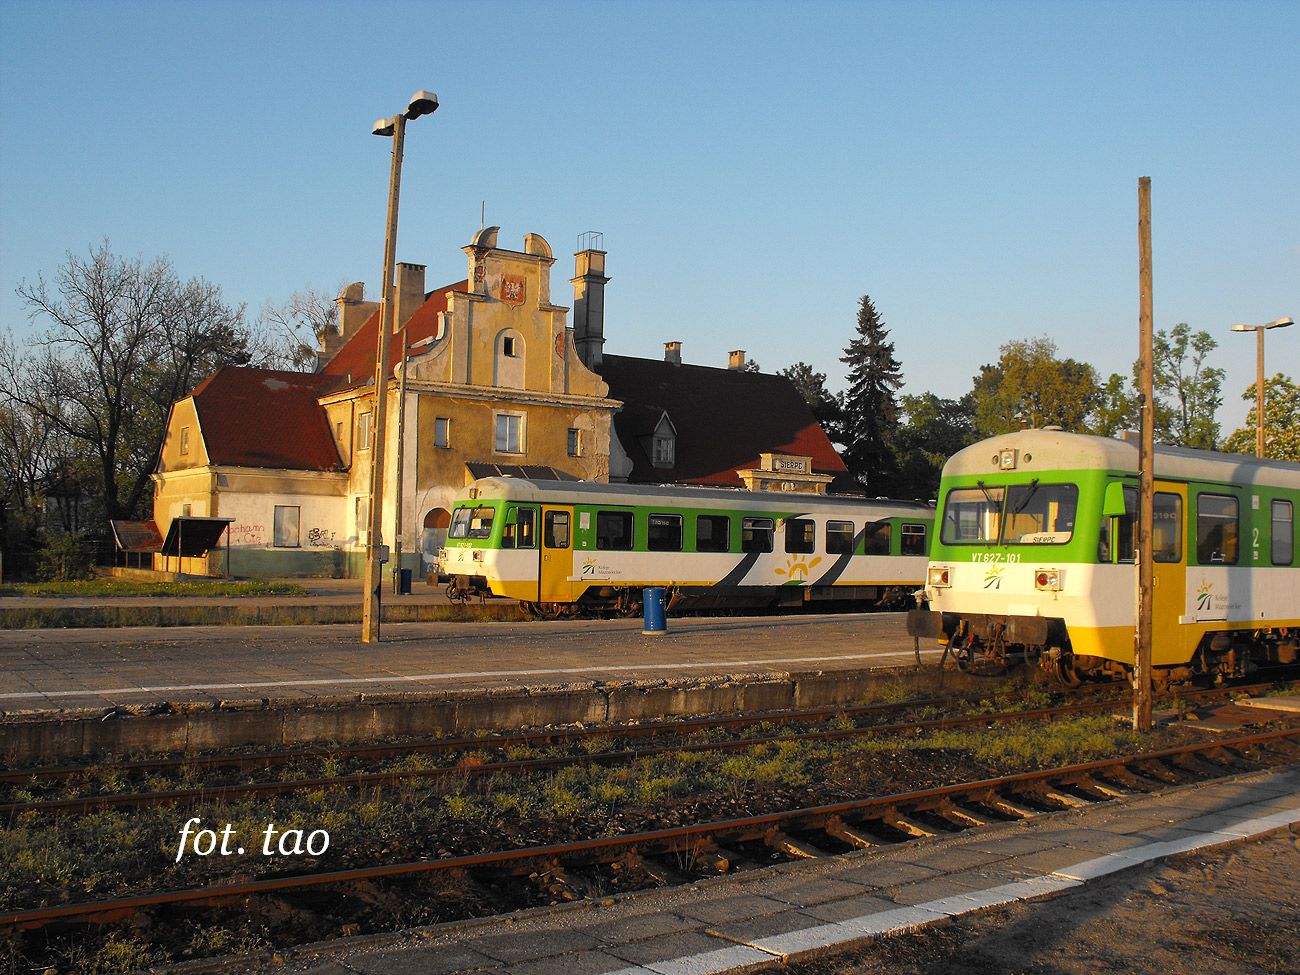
[1134,176,1156,732]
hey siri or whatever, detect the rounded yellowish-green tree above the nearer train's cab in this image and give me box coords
[971,335,1097,437]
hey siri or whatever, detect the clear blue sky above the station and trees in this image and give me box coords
[0,0,1300,433]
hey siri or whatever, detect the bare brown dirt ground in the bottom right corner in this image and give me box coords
[789,832,1300,975]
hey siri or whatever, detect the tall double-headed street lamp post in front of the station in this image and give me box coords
[361,91,438,644]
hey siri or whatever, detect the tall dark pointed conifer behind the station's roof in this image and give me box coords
[840,295,902,495]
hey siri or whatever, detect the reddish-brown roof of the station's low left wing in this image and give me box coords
[191,365,343,471]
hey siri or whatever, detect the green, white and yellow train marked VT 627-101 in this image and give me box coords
[909,429,1300,684]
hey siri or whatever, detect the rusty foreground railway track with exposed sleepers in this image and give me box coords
[0,728,1300,930]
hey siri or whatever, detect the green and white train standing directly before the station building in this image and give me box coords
[438,477,933,616]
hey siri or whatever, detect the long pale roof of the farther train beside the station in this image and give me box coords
[463,477,935,517]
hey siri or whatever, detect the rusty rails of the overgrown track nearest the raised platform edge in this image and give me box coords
[0,688,1279,819]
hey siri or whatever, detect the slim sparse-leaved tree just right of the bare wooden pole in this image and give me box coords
[1154,322,1223,450]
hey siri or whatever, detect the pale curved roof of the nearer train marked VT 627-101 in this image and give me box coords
[944,429,1300,488]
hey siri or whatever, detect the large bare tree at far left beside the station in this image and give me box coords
[0,239,254,519]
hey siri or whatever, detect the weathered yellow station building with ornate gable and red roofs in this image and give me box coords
[152,228,853,577]
